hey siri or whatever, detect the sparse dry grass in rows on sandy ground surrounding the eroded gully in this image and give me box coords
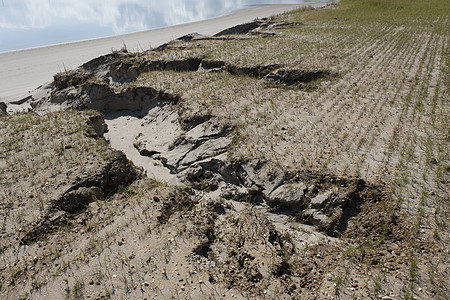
[0,0,450,299]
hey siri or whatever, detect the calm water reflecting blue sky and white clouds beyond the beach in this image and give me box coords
[0,0,329,52]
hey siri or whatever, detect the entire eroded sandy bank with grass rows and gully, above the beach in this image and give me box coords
[0,0,450,299]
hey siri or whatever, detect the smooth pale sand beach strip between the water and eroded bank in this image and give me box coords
[0,3,324,103]
